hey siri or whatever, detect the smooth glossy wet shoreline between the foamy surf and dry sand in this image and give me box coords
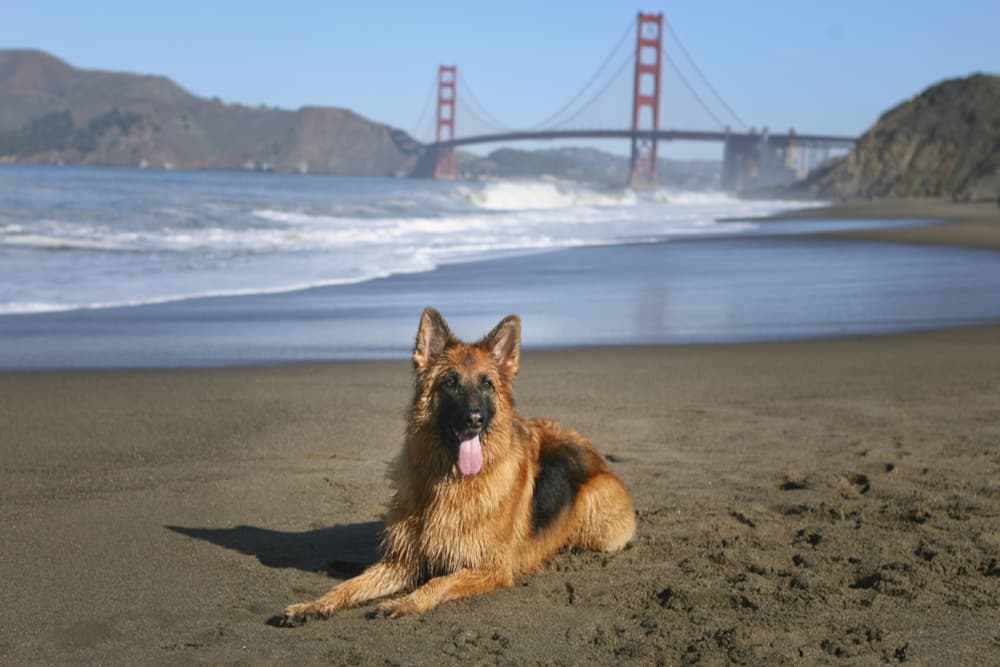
[0,201,1000,372]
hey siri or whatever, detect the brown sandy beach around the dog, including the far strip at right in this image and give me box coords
[0,197,1000,665]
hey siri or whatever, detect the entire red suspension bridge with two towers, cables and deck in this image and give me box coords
[410,12,856,191]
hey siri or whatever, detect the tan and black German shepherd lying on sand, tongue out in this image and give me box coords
[276,308,635,625]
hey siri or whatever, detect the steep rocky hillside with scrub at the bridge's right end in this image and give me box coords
[795,74,1000,200]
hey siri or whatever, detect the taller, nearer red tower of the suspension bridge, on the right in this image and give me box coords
[629,12,663,187]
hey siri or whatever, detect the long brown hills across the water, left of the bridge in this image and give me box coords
[0,50,423,176]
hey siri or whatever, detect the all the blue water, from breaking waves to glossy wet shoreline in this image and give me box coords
[0,166,1000,370]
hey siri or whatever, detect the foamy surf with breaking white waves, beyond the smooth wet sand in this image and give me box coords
[0,170,816,314]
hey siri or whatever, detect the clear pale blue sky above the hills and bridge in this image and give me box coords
[0,0,1000,157]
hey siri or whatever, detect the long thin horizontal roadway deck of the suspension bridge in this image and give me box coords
[427,130,857,150]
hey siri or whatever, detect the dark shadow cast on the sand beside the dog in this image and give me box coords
[166,521,382,579]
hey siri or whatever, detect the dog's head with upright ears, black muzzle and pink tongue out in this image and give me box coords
[412,308,521,475]
